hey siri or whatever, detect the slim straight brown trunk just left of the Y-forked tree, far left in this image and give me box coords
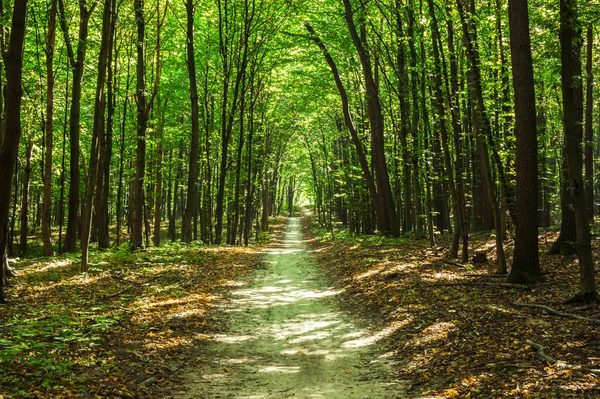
[42,0,58,256]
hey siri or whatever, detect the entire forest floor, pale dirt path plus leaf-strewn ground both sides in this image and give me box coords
[0,215,600,399]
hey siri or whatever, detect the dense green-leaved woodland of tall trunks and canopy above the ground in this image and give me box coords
[0,0,600,301]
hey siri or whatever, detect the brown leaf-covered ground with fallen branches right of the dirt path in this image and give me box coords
[304,211,600,399]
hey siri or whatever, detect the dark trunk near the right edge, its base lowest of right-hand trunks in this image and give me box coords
[560,0,600,303]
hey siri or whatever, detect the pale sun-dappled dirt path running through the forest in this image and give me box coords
[173,218,404,399]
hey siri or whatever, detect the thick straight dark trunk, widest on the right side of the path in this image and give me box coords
[508,0,542,284]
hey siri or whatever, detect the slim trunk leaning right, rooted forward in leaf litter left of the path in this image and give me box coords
[81,0,112,272]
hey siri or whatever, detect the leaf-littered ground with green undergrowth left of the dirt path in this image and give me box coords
[0,223,285,399]
